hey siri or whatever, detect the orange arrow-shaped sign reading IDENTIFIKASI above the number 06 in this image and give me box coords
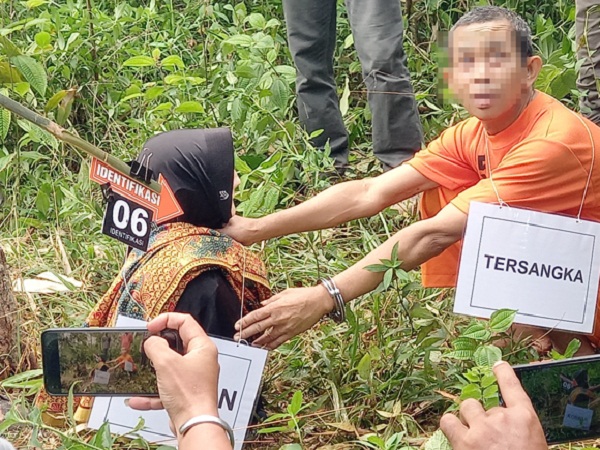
[90,158,183,223]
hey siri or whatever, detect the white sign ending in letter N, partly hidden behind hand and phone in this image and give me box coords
[88,316,268,450]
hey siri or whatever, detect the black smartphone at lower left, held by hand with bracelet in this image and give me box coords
[42,328,183,396]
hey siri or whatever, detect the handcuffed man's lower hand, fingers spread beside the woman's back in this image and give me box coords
[234,286,334,350]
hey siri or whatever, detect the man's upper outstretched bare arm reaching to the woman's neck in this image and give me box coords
[222,164,438,245]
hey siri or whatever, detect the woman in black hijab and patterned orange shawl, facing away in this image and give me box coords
[88,128,270,338]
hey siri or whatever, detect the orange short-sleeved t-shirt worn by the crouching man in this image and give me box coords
[407,91,600,342]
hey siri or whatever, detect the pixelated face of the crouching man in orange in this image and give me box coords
[447,20,539,133]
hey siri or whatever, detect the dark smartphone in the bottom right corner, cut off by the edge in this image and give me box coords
[514,355,600,444]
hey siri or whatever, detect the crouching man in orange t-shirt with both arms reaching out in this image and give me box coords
[224,6,600,352]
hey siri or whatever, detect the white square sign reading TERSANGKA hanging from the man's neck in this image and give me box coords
[454,202,600,333]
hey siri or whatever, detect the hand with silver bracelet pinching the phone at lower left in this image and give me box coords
[129,313,231,450]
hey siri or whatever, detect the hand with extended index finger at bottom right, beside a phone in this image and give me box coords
[440,361,548,450]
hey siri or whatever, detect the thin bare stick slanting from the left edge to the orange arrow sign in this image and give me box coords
[0,94,161,193]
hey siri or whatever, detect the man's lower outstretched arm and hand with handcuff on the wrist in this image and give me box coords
[234,204,467,349]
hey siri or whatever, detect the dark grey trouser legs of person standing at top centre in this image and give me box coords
[283,0,423,167]
